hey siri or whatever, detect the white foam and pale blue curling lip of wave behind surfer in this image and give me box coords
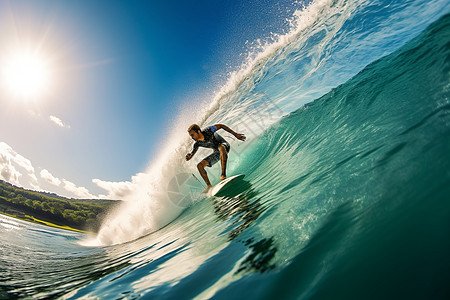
[91,0,443,245]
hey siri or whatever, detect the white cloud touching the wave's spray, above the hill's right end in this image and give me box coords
[92,173,148,200]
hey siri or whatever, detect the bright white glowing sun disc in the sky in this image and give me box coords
[2,52,50,99]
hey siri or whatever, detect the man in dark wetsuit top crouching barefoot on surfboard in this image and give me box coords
[186,124,246,193]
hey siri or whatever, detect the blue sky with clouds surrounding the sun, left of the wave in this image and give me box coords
[0,0,302,197]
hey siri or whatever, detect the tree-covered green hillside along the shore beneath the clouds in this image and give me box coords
[0,180,121,232]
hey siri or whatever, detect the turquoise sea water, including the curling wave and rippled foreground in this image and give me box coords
[0,1,450,299]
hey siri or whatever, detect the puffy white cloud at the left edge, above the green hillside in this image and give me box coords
[0,142,39,189]
